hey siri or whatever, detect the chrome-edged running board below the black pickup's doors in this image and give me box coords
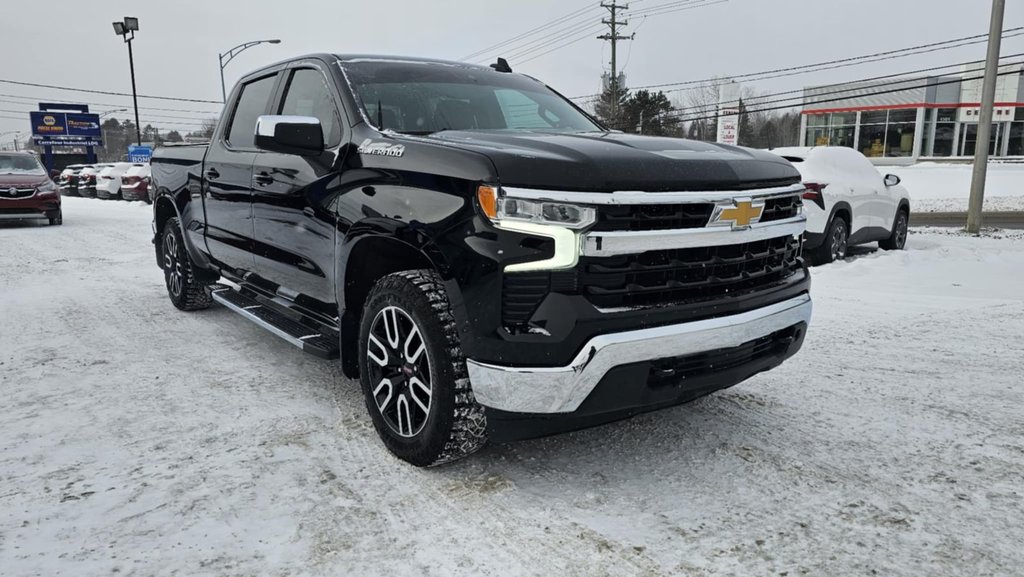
[211,285,339,359]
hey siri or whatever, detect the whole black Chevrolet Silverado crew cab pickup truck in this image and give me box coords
[153,54,811,465]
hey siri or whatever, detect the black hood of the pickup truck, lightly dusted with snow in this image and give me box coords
[415,130,800,192]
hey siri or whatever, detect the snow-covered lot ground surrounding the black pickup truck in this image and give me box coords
[6,199,1024,577]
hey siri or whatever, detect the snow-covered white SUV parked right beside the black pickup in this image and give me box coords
[772,147,910,264]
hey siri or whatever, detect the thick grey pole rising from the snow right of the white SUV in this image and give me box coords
[967,0,1007,235]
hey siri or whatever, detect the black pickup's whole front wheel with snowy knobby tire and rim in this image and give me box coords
[359,271,486,466]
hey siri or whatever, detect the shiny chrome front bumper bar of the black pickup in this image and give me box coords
[466,294,811,414]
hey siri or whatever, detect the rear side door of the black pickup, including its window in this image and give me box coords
[203,73,278,277]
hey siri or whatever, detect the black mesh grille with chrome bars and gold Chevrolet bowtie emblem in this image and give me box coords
[502,184,806,327]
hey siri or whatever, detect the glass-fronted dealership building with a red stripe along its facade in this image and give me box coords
[801,64,1024,164]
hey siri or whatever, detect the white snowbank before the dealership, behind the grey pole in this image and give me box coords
[879,162,1024,212]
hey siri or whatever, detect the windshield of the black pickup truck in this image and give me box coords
[341,60,602,134]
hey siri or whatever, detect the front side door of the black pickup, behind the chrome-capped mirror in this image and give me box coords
[252,63,345,305]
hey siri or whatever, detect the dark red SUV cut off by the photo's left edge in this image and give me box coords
[0,153,63,224]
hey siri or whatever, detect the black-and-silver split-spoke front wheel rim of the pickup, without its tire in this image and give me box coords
[367,306,433,438]
